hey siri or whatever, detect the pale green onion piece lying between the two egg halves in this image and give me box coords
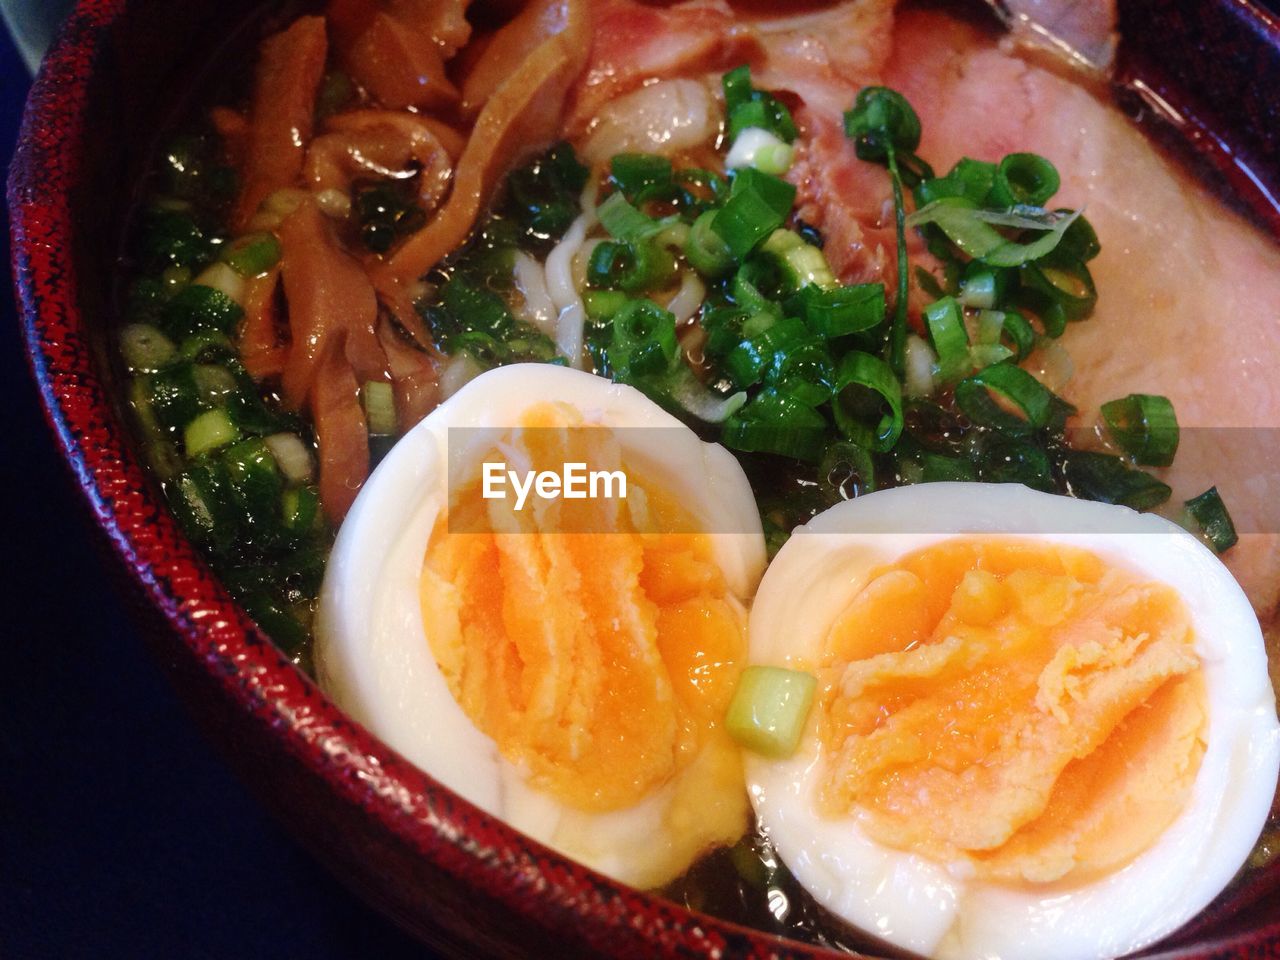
[724,666,818,760]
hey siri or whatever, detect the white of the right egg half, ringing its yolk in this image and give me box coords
[746,483,1280,960]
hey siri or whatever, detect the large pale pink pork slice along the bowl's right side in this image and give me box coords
[884,12,1280,617]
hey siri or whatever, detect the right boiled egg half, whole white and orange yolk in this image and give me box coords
[746,483,1280,960]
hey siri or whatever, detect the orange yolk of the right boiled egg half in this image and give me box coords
[819,539,1207,883]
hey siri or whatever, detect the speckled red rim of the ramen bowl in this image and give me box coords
[15,0,1280,960]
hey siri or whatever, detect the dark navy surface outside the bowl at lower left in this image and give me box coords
[0,24,431,960]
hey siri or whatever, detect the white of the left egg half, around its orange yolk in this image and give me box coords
[316,364,765,886]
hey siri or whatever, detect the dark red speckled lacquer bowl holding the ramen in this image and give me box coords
[9,0,1280,957]
